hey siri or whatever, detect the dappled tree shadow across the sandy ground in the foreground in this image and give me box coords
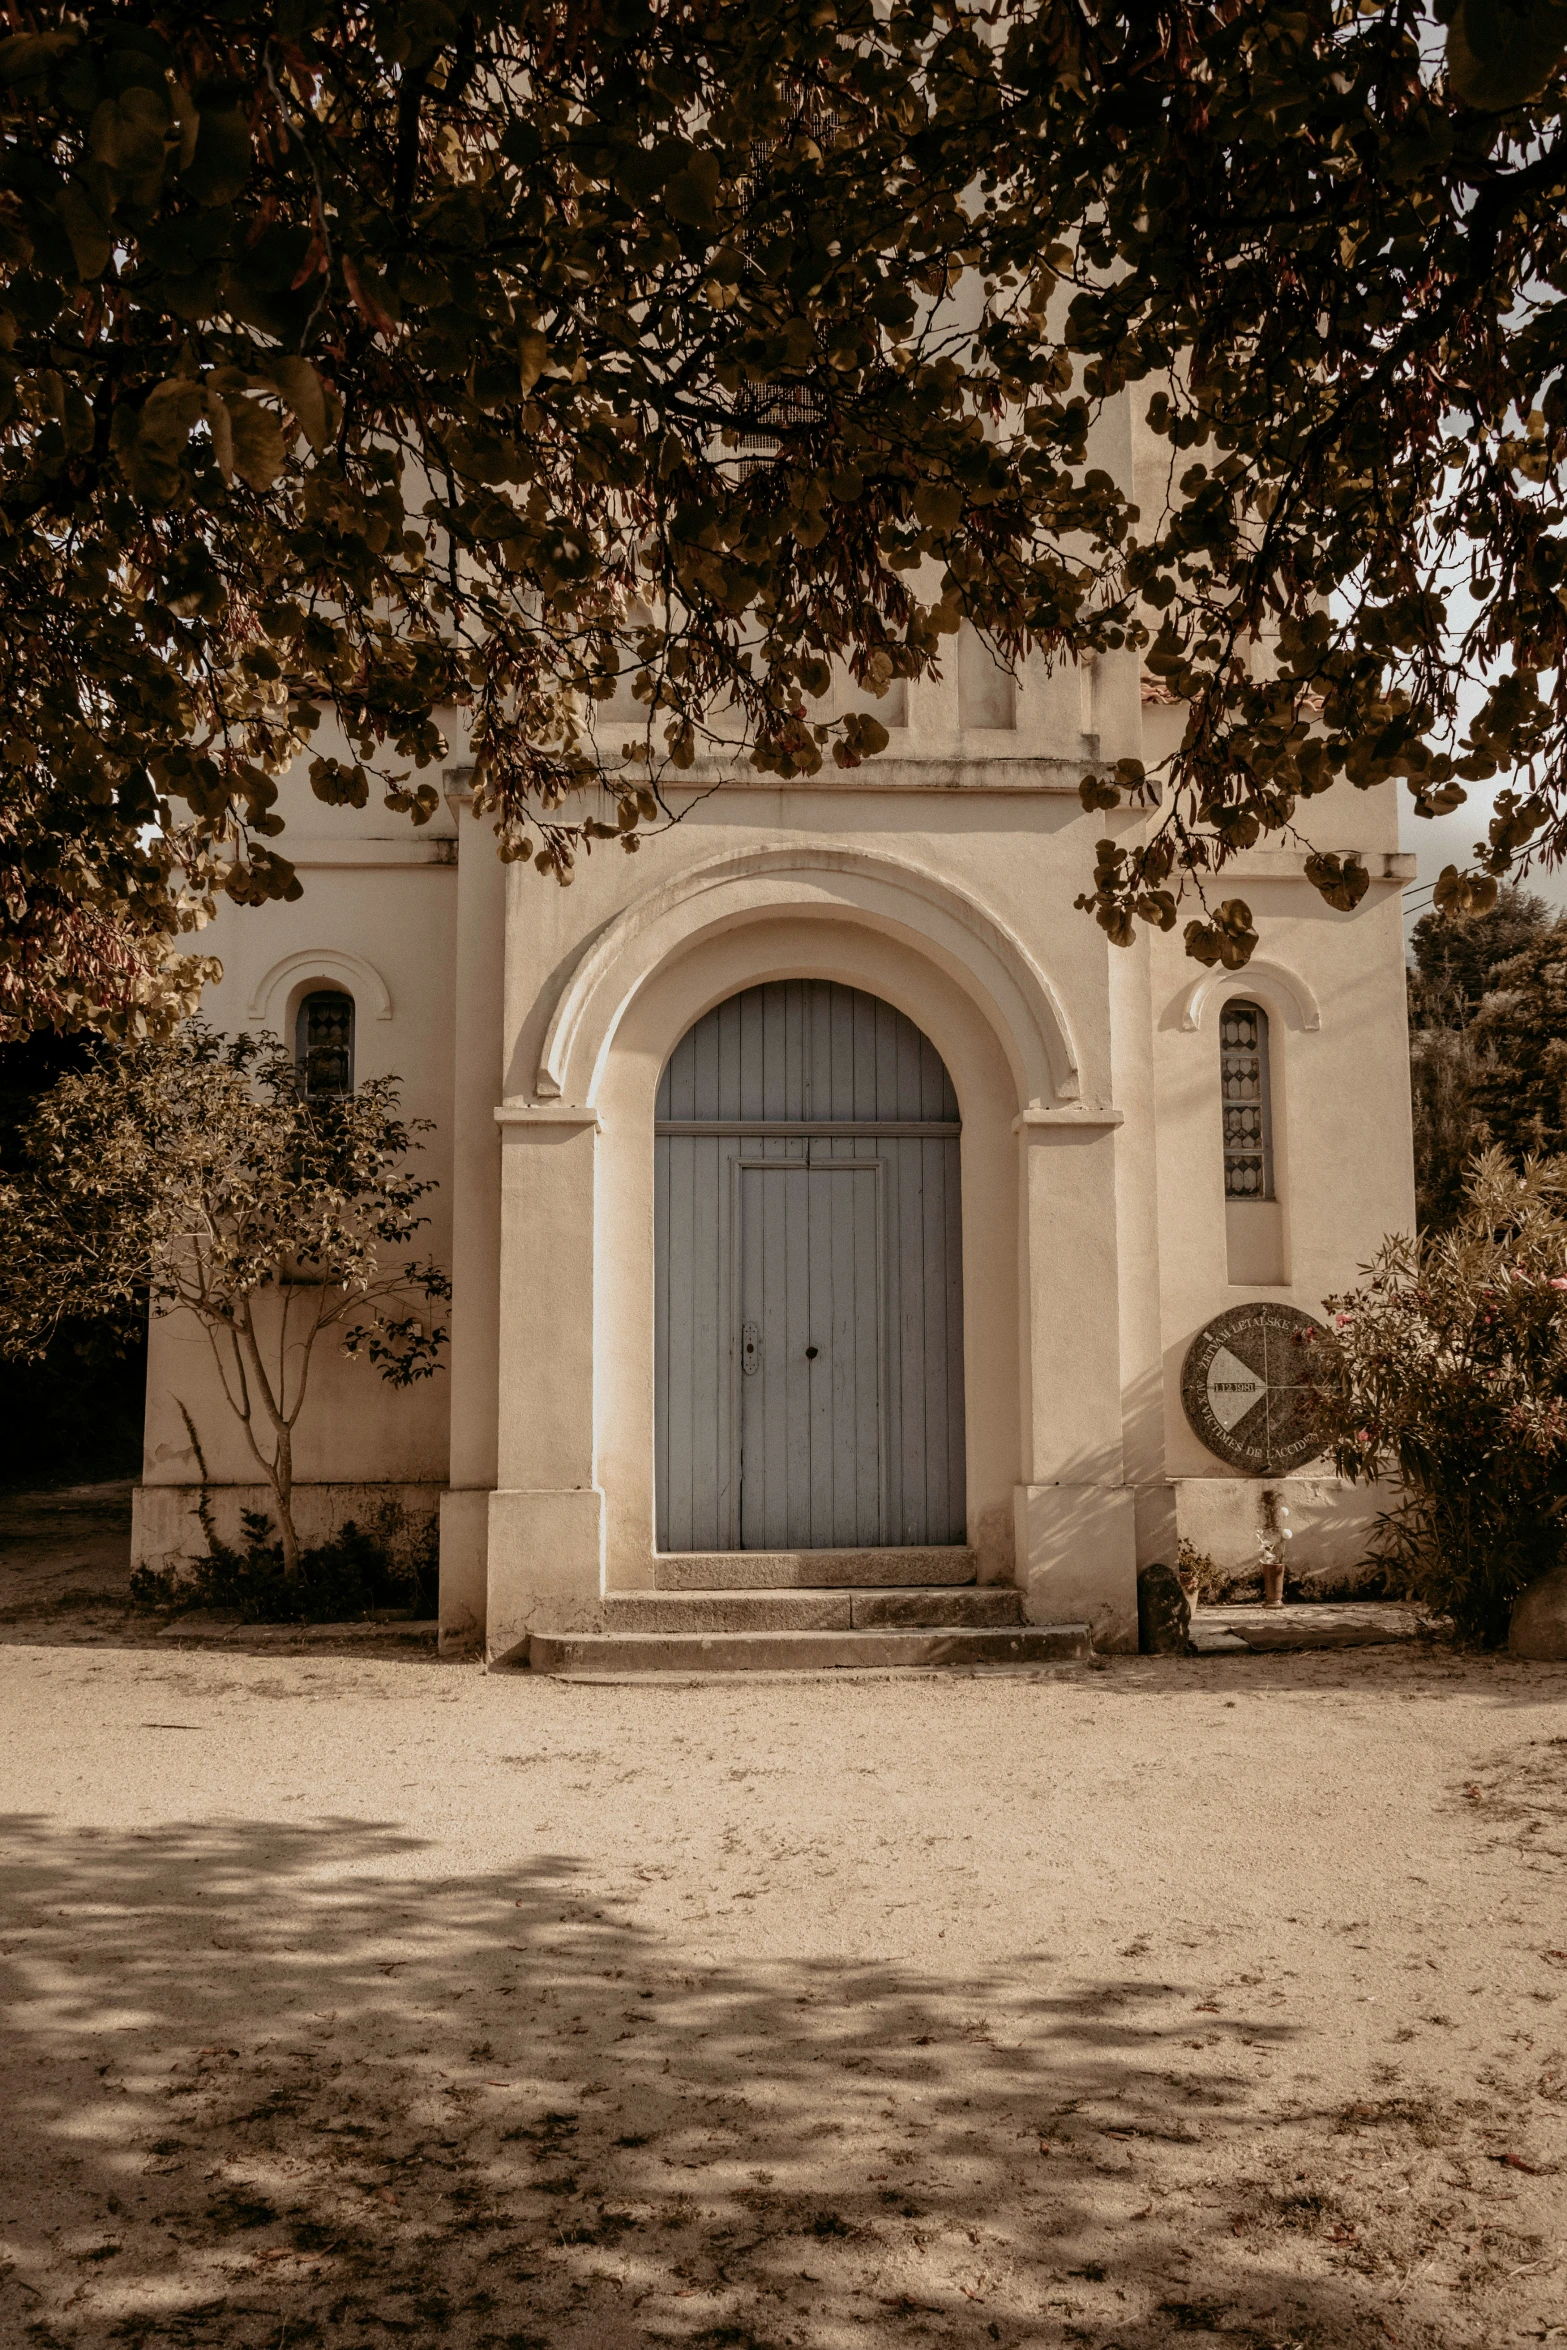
[0,1804,1522,2350]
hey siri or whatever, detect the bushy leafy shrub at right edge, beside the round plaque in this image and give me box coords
[1316,1149,1567,1647]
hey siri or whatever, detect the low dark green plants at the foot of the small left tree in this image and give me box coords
[132,1504,435,1624]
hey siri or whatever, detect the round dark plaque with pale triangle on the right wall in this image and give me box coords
[1182,1300,1327,1476]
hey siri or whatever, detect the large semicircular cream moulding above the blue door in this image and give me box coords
[536,846,1078,1107]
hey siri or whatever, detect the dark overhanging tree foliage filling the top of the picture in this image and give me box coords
[0,0,1567,1027]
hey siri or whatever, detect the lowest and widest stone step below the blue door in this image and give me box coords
[529,1624,1092,1676]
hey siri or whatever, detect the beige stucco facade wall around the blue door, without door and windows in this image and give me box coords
[141,394,1412,1657]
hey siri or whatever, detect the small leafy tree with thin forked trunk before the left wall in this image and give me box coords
[0,1022,451,1579]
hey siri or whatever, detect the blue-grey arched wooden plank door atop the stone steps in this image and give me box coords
[655,980,966,1551]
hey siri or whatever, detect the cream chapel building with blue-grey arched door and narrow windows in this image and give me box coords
[136,394,1414,1664]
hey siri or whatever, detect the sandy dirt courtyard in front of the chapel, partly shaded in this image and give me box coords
[0,1610,1567,2350]
